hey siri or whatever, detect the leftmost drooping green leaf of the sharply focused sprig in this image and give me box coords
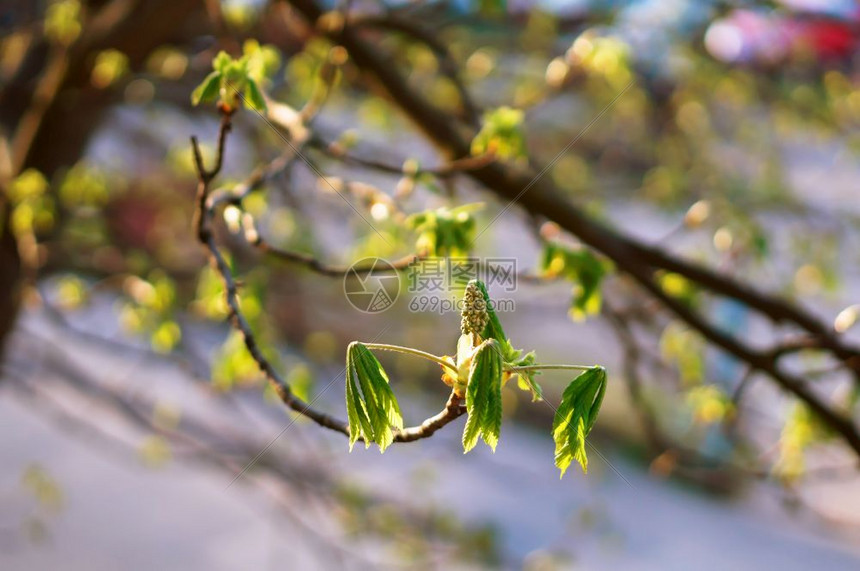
[346,342,403,452]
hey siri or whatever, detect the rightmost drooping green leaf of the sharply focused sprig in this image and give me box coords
[552,367,606,477]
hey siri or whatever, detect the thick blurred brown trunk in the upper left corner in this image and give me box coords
[0,0,206,360]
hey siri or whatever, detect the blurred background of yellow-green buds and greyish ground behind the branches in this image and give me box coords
[0,0,860,570]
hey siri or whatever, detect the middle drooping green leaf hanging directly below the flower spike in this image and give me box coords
[463,339,502,453]
